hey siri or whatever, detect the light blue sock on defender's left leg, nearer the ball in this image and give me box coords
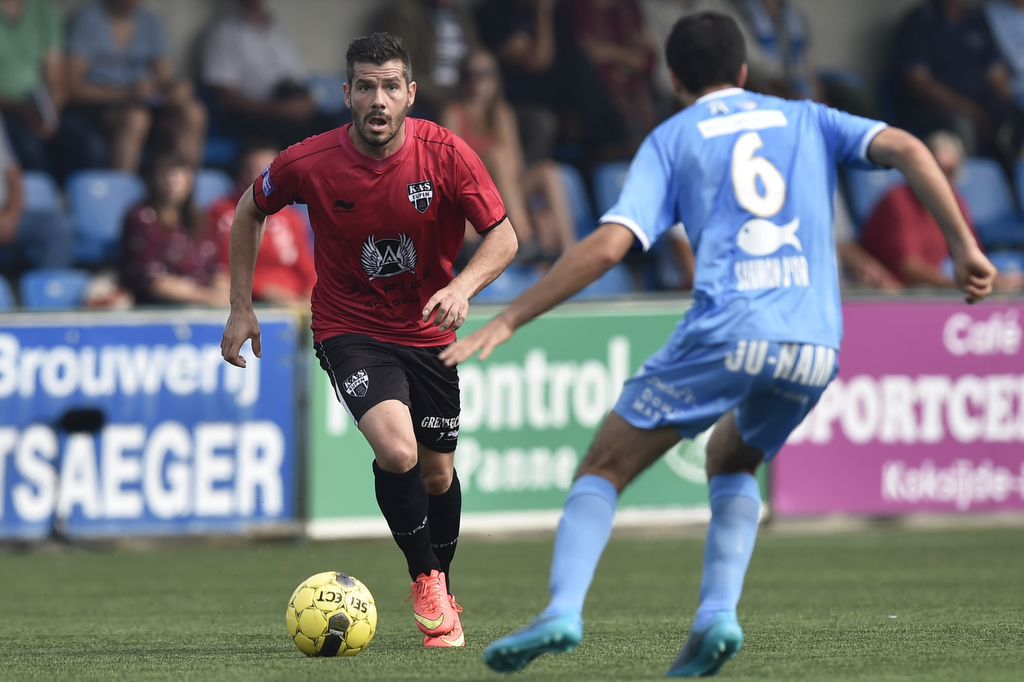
[544,474,618,613]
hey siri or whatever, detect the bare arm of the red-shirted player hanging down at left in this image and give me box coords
[220,186,266,367]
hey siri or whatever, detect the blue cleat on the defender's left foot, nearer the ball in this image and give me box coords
[483,610,583,673]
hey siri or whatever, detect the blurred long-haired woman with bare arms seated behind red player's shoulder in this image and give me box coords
[441,50,575,261]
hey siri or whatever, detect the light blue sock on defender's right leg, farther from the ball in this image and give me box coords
[693,473,761,630]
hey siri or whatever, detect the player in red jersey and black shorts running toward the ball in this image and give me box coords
[221,33,517,646]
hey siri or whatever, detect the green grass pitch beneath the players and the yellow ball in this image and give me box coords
[0,529,1024,682]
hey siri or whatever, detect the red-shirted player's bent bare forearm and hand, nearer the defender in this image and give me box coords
[423,218,519,332]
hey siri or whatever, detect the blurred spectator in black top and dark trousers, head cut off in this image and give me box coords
[476,0,633,163]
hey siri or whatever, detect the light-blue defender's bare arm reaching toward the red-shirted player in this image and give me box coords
[439,222,633,367]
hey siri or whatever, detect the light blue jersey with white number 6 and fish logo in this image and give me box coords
[600,88,885,349]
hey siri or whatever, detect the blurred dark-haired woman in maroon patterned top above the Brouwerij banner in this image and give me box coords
[121,153,229,306]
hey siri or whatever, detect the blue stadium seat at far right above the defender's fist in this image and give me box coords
[956,158,1024,249]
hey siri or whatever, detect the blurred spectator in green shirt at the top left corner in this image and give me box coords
[0,0,65,170]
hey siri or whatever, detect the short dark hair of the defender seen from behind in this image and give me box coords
[665,12,746,94]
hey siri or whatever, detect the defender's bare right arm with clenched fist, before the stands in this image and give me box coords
[867,128,995,303]
